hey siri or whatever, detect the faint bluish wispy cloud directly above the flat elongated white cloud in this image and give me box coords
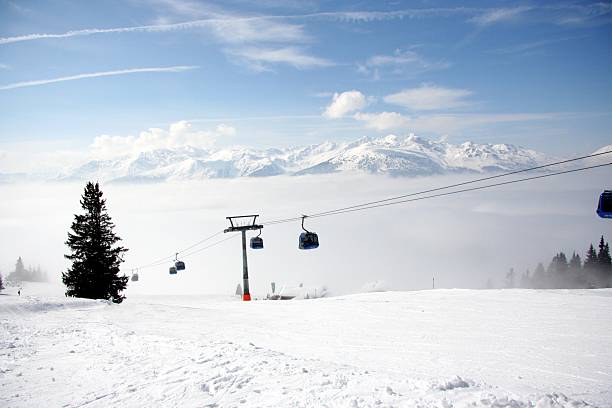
[357,49,450,80]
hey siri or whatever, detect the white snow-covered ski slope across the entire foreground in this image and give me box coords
[0,287,612,408]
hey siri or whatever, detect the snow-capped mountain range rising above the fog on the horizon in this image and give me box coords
[59,135,544,181]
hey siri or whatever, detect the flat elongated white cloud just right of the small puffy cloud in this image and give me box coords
[384,85,472,111]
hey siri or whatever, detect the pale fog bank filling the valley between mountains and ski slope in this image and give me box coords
[0,168,612,296]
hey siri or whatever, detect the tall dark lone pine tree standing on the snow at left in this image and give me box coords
[62,182,128,303]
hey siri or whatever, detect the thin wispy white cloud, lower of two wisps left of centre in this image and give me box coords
[227,47,334,71]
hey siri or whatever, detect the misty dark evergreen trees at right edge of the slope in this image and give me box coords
[505,236,612,289]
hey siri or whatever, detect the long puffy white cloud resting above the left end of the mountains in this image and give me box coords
[90,121,236,159]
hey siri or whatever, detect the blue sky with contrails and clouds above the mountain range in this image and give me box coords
[0,0,612,171]
